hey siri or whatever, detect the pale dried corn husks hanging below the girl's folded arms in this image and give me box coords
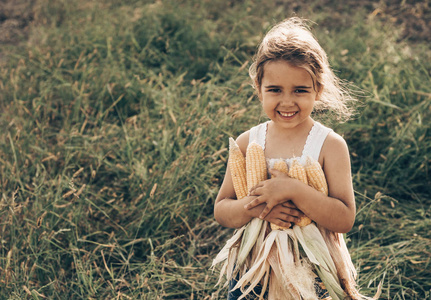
[212,139,379,300]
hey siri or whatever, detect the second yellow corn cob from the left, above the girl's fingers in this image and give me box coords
[245,142,268,191]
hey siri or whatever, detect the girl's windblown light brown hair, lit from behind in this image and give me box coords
[249,17,354,120]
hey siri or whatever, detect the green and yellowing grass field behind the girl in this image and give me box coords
[0,0,431,299]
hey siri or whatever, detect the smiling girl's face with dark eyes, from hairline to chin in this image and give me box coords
[259,60,320,128]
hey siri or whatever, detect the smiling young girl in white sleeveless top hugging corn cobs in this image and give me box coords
[214,18,355,299]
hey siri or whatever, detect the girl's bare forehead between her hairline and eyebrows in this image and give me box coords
[262,60,313,86]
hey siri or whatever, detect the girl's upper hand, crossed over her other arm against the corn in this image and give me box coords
[244,169,293,219]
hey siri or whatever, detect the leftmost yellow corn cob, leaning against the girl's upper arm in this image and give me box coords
[228,138,248,199]
